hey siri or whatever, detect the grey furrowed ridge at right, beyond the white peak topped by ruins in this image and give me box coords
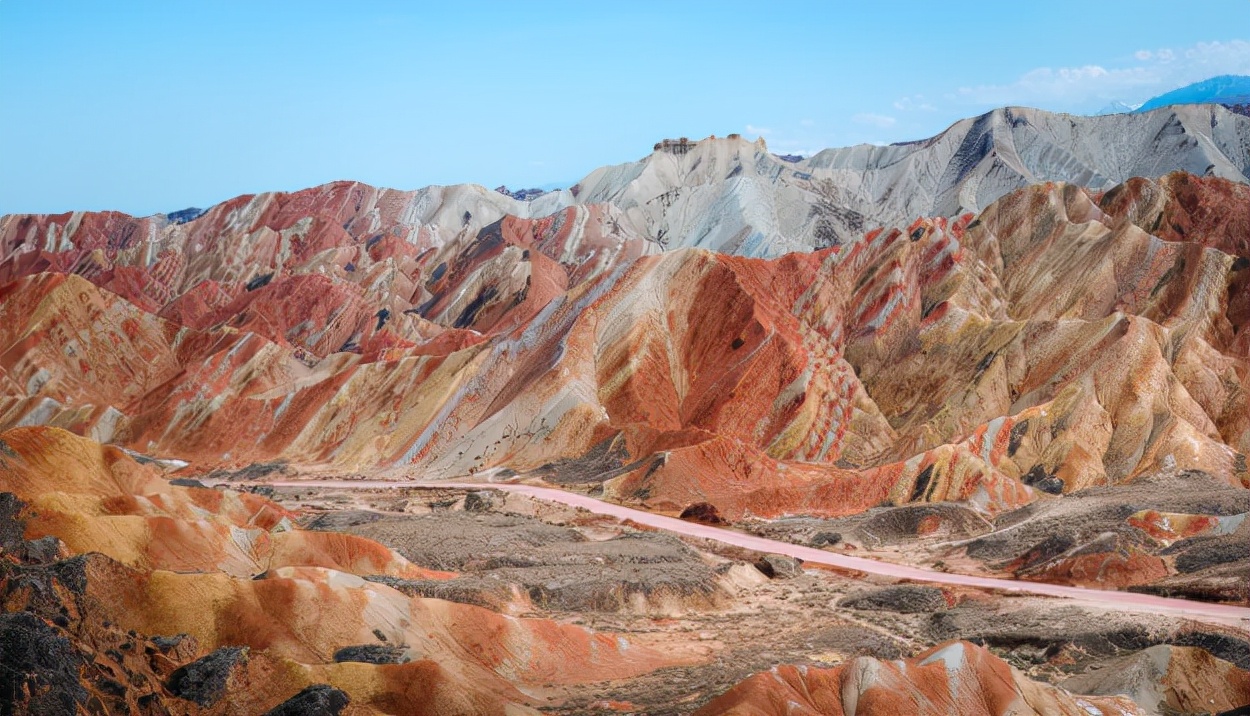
[805,105,1250,244]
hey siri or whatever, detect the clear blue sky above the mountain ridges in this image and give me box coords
[0,0,1250,214]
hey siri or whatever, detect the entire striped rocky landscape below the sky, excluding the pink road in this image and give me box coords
[0,106,1250,716]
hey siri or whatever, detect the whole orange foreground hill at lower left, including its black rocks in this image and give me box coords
[0,427,700,715]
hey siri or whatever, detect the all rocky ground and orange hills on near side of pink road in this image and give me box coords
[7,427,1250,716]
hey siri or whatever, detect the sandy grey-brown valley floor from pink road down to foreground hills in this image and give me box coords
[246,481,1250,714]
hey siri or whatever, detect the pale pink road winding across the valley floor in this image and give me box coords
[256,480,1250,629]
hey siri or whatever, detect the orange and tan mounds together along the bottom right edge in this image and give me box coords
[699,641,1250,716]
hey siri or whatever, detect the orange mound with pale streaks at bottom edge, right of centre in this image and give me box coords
[698,641,1141,716]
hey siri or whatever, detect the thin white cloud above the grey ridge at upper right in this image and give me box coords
[948,40,1250,110]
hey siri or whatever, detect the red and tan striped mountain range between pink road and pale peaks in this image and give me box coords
[0,168,1250,597]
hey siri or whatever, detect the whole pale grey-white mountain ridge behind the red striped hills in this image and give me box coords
[557,105,1250,256]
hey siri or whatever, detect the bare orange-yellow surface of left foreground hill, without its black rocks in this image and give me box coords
[0,427,698,715]
